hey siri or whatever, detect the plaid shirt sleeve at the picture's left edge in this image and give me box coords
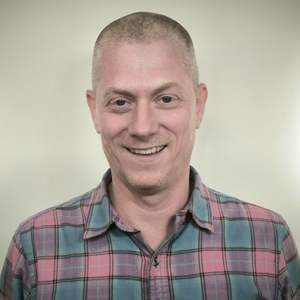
[0,229,30,300]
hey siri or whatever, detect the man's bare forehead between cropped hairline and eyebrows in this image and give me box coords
[97,41,191,93]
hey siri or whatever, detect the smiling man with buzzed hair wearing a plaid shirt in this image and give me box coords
[0,13,300,300]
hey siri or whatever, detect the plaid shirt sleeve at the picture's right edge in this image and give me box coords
[278,226,300,300]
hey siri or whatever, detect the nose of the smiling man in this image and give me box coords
[128,101,159,138]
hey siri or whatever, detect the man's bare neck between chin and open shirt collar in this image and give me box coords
[108,174,189,251]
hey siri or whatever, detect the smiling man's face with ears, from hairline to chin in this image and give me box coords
[87,42,207,192]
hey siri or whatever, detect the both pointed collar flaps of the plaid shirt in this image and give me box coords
[83,167,214,239]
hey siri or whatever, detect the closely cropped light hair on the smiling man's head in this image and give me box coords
[92,12,199,93]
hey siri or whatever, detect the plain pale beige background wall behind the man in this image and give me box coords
[0,0,300,264]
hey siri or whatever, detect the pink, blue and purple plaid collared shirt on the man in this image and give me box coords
[0,168,300,300]
